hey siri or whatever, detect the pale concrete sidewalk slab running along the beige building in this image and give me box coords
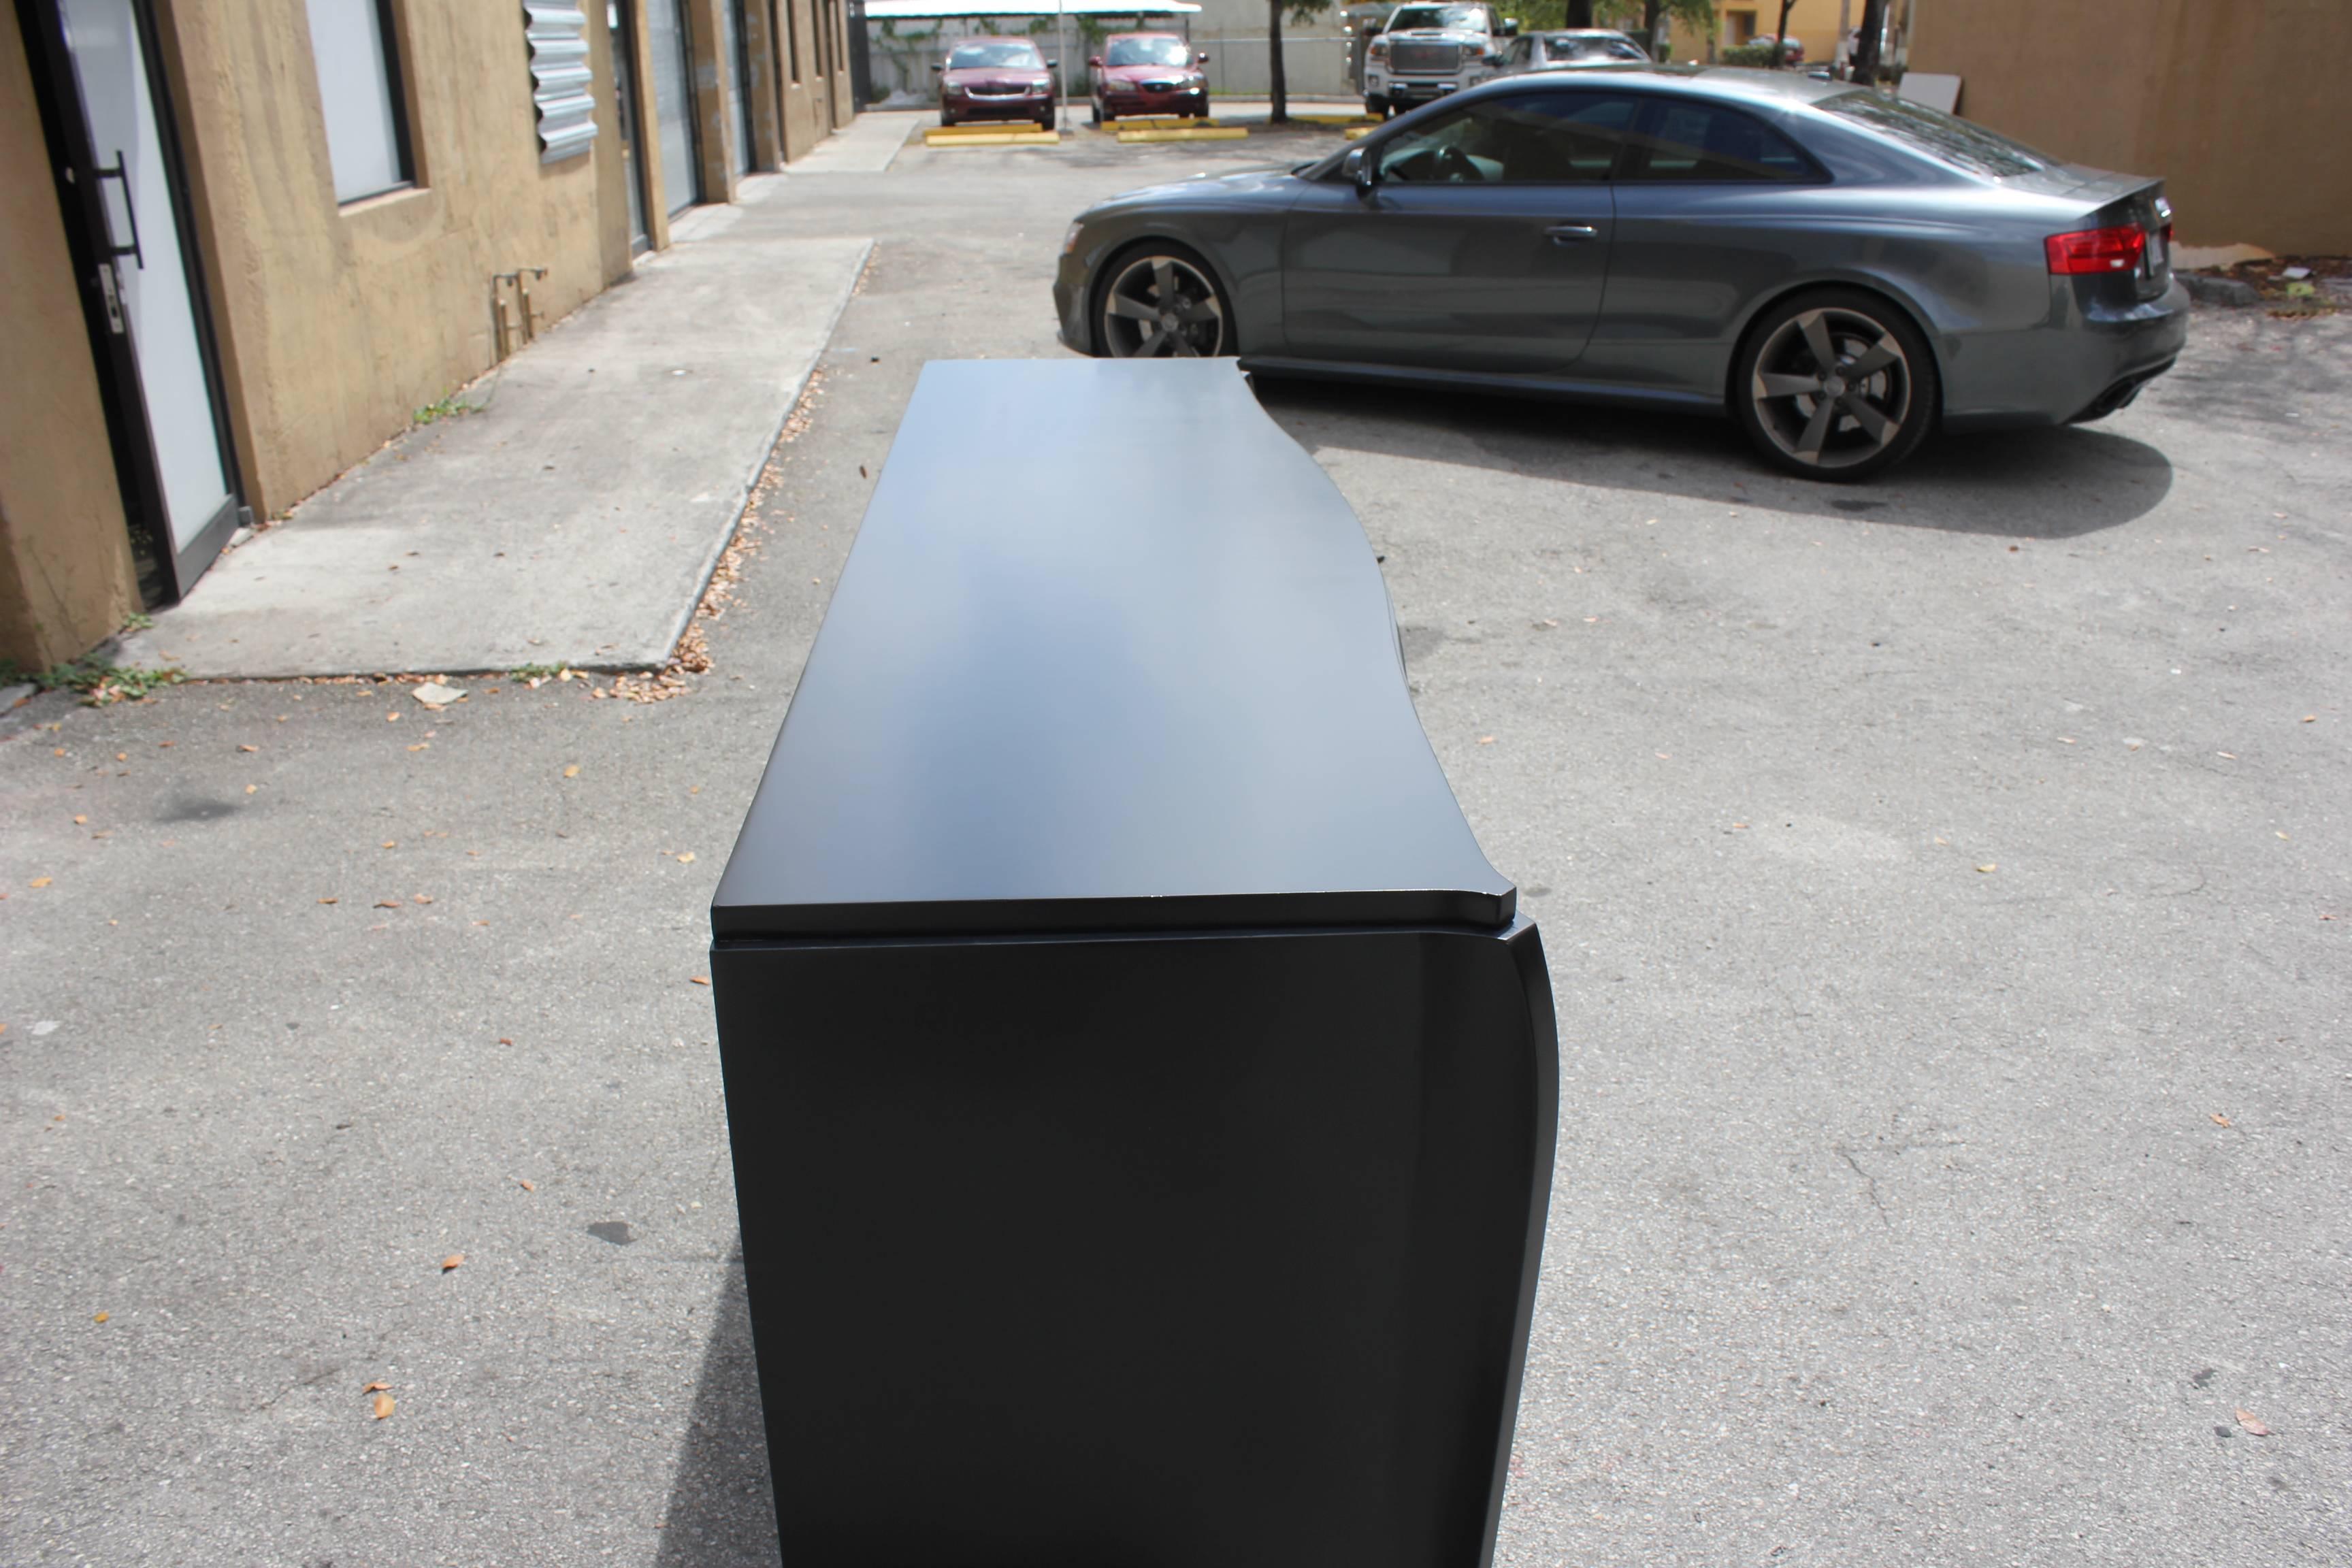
[122,180,875,677]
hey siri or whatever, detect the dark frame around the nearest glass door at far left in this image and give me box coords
[16,0,252,604]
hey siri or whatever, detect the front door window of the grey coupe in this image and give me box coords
[1378,92,1637,186]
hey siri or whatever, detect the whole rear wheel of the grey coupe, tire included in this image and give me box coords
[1731,289,1938,482]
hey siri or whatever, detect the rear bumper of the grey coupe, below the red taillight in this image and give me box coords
[1943,278,2190,430]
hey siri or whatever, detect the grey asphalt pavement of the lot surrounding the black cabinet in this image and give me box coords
[0,116,2352,1568]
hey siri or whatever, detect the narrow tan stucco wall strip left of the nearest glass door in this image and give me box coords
[0,16,139,670]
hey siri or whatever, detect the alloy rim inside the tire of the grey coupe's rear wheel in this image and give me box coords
[1748,306,1914,470]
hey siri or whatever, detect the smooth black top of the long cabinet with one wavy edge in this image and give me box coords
[710,360,1515,938]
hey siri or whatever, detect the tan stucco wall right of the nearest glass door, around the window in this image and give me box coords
[158,0,628,514]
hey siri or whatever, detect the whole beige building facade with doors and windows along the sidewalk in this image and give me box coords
[0,0,854,670]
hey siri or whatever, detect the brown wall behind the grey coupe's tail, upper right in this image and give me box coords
[1910,0,2352,254]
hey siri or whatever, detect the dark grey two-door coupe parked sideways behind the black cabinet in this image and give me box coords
[1054,68,2187,480]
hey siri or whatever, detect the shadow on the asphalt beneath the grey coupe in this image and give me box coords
[1256,376,2173,538]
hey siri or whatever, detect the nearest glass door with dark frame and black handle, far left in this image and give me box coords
[28,0,238,600]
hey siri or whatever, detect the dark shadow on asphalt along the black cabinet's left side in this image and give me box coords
[654,1251,779,1568]
